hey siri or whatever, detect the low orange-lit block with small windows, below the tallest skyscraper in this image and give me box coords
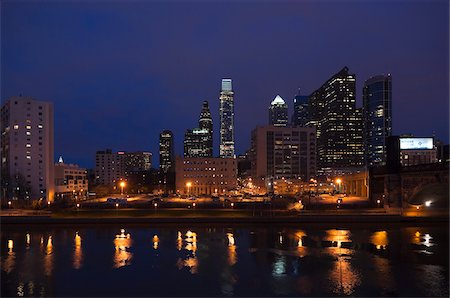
[176,157,237,196]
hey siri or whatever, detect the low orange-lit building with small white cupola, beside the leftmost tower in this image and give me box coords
[54,158,89,200]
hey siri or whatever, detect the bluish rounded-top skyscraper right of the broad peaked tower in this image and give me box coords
[363,74,392,166]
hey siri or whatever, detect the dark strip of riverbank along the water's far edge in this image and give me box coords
[0,211,449,224]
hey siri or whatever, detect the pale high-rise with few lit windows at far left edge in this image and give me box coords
[0,96,54,202]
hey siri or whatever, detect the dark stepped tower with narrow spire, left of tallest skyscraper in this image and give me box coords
[184,101,213,157]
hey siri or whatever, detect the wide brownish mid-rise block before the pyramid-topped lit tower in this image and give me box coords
[249,125,316,181]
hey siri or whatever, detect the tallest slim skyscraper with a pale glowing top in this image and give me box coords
[219,79,234,157]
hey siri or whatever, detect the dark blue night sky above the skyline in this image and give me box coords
[1,0,449,167]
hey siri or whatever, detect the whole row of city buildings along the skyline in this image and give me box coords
[0,67,449,202]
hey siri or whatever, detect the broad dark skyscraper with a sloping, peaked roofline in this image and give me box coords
[307,67,364,174]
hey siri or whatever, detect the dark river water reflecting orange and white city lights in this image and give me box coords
[1,223,449,297]
